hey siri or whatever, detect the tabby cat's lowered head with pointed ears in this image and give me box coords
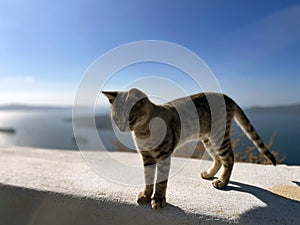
[102,88,151,131]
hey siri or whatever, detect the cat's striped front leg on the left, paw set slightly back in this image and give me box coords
[137,152,156,205]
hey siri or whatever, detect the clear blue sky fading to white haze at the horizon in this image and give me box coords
[0,0,300,106]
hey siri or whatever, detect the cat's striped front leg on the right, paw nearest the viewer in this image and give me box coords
[151,156,171,209]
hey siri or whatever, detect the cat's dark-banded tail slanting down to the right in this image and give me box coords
[234,104,276,166]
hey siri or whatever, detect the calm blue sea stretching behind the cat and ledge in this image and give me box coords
[0,110,300,165]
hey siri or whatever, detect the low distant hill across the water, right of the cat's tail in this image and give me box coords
[246,103,300,114]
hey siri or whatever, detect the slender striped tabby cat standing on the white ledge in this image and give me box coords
[102,88,276,209]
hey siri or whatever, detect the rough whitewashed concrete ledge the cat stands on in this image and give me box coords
[0,147,300,225]
